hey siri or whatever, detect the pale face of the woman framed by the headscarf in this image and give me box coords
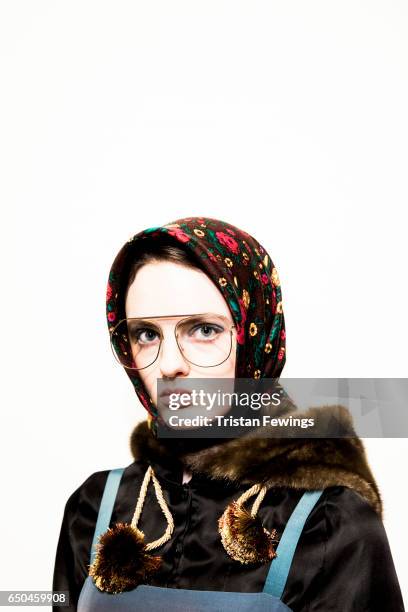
[125,261,236,418]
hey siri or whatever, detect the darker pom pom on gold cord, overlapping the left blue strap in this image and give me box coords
[89,523,161,593]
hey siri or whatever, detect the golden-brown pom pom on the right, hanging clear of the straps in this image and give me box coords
[218,501,277,563]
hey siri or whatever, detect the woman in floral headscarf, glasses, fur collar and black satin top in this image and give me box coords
[53,217,403,612]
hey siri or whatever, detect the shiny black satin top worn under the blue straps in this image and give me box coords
[53,461,404,612]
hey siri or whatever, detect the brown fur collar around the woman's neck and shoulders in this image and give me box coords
[130,405,383,517]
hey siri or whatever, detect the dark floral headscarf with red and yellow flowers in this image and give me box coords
[106,217,286,423]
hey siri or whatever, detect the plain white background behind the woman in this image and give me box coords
[0,0,408,608]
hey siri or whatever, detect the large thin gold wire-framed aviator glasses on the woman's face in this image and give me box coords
[110,313,235,370]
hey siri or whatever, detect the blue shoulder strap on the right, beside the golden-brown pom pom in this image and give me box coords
[263,491,323,599]
